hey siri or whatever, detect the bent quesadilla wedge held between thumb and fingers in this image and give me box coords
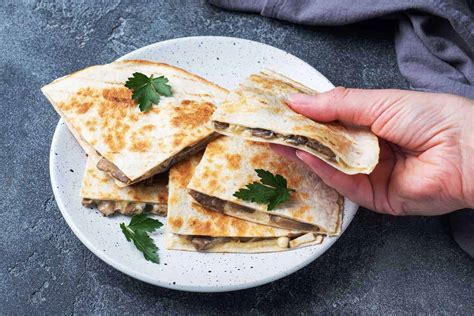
[212,70,379,174]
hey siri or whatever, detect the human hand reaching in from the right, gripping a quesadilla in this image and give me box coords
[272,87,474,215]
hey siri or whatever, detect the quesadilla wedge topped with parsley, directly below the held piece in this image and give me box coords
[188,137,343,235]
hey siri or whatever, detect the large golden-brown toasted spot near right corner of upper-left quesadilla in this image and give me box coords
[171,100,214,128]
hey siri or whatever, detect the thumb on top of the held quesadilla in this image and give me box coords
[288,87,402,127]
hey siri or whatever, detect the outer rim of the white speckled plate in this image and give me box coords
[49,36,358,292]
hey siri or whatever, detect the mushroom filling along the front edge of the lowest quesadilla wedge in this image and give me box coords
[186,233,321,252]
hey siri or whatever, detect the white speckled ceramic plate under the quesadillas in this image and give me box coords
[50,36,357,292]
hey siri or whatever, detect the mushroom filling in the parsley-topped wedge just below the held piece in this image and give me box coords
[189,190,319,232]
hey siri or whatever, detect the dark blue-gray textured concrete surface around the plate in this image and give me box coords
[0,1,474,314]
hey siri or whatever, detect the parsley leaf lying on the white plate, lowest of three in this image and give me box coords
[120,213,163,263]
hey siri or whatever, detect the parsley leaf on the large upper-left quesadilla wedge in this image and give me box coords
[125,72,172,112]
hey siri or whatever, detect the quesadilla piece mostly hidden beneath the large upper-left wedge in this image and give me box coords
[80,156,168,216]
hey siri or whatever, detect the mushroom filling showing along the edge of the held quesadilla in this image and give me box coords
[213,121,336,162]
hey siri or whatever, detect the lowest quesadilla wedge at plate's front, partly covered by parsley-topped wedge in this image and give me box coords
[165,156,323,253]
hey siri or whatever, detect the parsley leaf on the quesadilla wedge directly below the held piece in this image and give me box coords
[234,169,295,211]
